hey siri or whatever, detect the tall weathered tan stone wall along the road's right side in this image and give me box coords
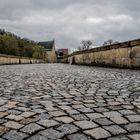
[63,39,140,68]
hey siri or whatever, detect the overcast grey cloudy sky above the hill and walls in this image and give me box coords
[0,0,140,49]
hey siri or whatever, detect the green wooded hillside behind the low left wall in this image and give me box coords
[0,29,44,59]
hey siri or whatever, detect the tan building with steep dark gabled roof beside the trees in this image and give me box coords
[38,40,57,63]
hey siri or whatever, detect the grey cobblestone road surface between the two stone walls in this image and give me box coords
[0,64,140,140]
